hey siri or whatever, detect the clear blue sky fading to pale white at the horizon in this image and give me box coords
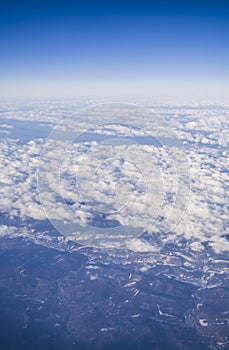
[0,0,229,99]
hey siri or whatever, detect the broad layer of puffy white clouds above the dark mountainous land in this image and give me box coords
[0,105,229,262]
